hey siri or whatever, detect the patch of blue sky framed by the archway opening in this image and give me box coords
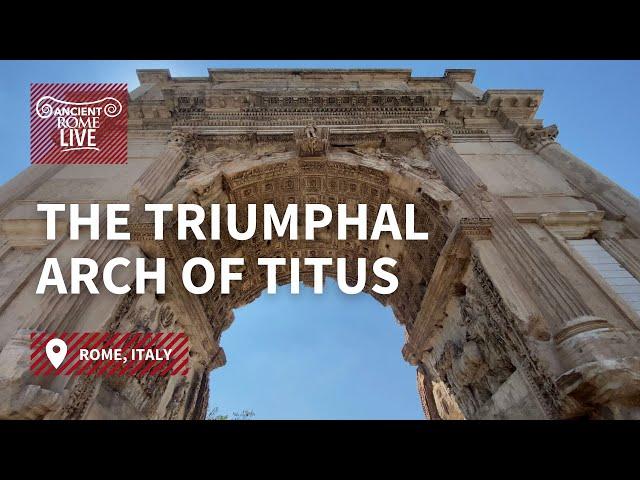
[209,278,424,419]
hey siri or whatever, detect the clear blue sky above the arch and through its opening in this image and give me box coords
[0,60,640,418]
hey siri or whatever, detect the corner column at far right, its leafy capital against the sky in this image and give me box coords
[516,125,640,235]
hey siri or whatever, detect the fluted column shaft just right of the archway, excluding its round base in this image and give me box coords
[424,129,593,334]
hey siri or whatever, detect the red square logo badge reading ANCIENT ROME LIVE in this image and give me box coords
[31,83,129,164]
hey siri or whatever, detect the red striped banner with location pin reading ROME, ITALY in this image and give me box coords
[31,332,190,378]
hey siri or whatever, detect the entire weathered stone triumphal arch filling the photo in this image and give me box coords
[0,69,640,419]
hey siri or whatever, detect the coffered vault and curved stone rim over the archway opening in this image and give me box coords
[132,137,456,418]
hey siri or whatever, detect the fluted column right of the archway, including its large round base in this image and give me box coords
[424,129,640,418]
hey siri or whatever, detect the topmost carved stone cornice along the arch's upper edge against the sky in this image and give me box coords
[130,69,542,126]
